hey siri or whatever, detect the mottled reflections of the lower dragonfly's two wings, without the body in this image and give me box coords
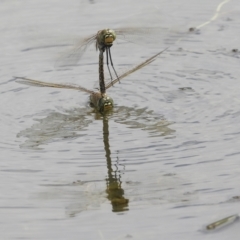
[17,106,175,150]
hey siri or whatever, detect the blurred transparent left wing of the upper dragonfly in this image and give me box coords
[55,34,96,67]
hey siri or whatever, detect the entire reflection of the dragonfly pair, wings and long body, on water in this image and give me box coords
[17,107,174,214]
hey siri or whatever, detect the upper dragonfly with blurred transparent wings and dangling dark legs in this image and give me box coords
[56,27,182,80]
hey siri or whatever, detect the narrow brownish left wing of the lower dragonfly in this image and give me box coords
[15,77,94,94]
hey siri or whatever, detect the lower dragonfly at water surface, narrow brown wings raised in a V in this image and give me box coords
[15,48,167,113]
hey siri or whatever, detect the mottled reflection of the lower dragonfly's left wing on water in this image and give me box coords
[17,108,94,150]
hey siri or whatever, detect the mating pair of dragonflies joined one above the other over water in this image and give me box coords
[16,29,166,112]
